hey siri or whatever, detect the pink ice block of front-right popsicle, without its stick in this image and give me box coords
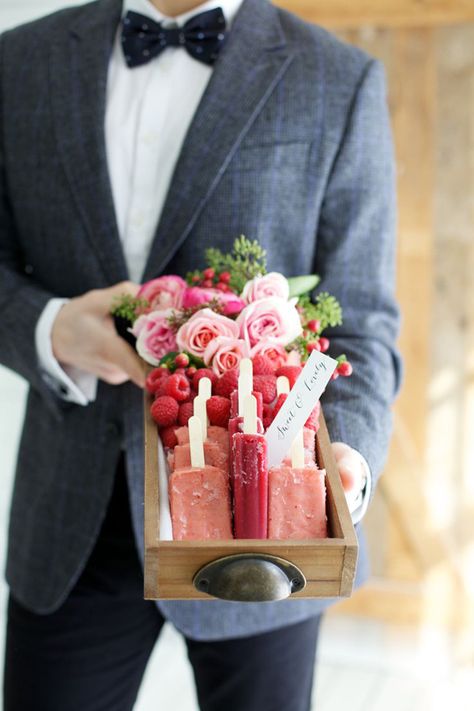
[268,464,328,540]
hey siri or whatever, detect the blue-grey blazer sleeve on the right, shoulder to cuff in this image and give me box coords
[314,60,401,492]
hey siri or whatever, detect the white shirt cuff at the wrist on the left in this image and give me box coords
[35,299,97,405]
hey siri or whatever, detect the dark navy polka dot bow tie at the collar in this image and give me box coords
[122,7,226,67]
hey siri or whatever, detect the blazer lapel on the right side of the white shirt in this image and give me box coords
[143,0,293,281]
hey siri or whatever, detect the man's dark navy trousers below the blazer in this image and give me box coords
[4,458,320,711]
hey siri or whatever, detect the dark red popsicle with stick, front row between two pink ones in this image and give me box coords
[231,395,268,538]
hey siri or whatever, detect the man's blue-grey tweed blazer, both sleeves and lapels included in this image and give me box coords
[0,0,399,639]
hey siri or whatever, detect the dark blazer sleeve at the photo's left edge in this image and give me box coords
[0,37,61,417]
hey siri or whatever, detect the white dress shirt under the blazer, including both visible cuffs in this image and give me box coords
[35,0,370,521]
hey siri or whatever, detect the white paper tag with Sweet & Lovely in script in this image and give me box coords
[265,351,337,468]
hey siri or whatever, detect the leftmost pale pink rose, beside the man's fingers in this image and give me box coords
[130,309,176,365]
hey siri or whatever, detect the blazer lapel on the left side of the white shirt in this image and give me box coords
[50,0,127,283]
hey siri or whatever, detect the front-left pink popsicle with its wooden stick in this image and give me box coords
[169,415,232,541]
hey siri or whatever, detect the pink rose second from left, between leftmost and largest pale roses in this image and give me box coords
[176,309,239,358]
